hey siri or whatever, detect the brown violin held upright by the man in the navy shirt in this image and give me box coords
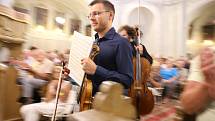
[78,42,100,111]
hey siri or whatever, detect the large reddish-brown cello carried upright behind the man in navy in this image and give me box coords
[130,5,154,118]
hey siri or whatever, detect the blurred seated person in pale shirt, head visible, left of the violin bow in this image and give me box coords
[15,49,54,104]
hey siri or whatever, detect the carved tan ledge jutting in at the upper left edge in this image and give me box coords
[0,5,30,44]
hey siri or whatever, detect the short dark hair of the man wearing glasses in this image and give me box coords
[89,0,115,14]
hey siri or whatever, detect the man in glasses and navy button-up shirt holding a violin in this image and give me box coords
[81,0,133,95]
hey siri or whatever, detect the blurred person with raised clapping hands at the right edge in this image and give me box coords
[181,48,215,121]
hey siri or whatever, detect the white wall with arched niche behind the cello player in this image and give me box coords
[111,0,215,57]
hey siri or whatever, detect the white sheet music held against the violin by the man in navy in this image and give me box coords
[68,32,94,86]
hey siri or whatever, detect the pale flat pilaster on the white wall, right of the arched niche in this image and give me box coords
[161,1,186,58]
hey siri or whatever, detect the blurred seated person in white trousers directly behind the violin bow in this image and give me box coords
[20,66,72,121]
